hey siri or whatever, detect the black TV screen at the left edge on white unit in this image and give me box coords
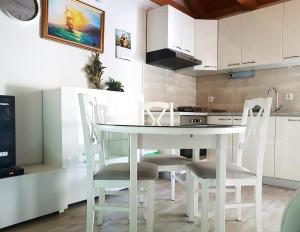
[0,95,16,168]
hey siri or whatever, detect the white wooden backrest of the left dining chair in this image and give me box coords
[78,93,107,177]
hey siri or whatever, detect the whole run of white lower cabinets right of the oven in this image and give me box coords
[207,116,300,181]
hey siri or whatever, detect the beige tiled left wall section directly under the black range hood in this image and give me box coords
[143,65,196,107]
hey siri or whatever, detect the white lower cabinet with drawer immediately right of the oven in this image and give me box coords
[207,116,233,162]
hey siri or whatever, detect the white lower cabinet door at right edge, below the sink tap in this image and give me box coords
[275,117,300,181]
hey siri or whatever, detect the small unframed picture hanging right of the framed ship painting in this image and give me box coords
[115,29,131,60]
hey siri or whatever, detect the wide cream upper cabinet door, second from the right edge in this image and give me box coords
[242,4,283,67]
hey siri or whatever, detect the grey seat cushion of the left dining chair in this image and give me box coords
[94,162,158,180]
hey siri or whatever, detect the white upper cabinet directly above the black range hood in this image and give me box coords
[147,5,194,56]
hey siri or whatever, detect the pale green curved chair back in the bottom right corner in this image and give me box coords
[280,189,300,232]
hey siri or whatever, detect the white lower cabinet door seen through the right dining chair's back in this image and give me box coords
[232,117,275,177]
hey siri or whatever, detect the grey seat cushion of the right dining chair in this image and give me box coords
[187,161,256,179]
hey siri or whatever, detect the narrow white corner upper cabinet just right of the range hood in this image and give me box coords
[194,19,218,70]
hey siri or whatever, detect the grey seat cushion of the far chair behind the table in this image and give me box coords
[141,155,191,166]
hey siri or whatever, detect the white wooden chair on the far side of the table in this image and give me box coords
[140,102,191,201]
